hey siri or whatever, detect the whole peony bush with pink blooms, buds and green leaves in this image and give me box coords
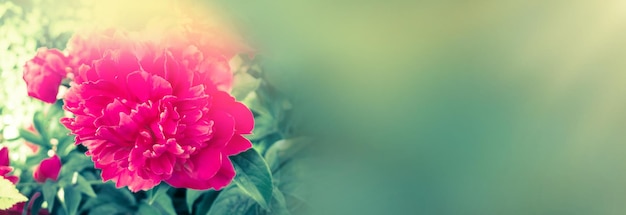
[0,3,307,214]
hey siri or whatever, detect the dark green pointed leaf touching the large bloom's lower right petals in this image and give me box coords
[231,149,274,210]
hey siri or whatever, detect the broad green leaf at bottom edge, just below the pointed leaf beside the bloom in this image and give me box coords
[207,186,255,215]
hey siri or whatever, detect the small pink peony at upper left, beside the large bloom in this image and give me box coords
[23,48,69,103]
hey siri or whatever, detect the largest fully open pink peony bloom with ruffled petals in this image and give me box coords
[61,33,254,192]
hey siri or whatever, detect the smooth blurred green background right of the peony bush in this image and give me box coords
[0,0,626,214]
